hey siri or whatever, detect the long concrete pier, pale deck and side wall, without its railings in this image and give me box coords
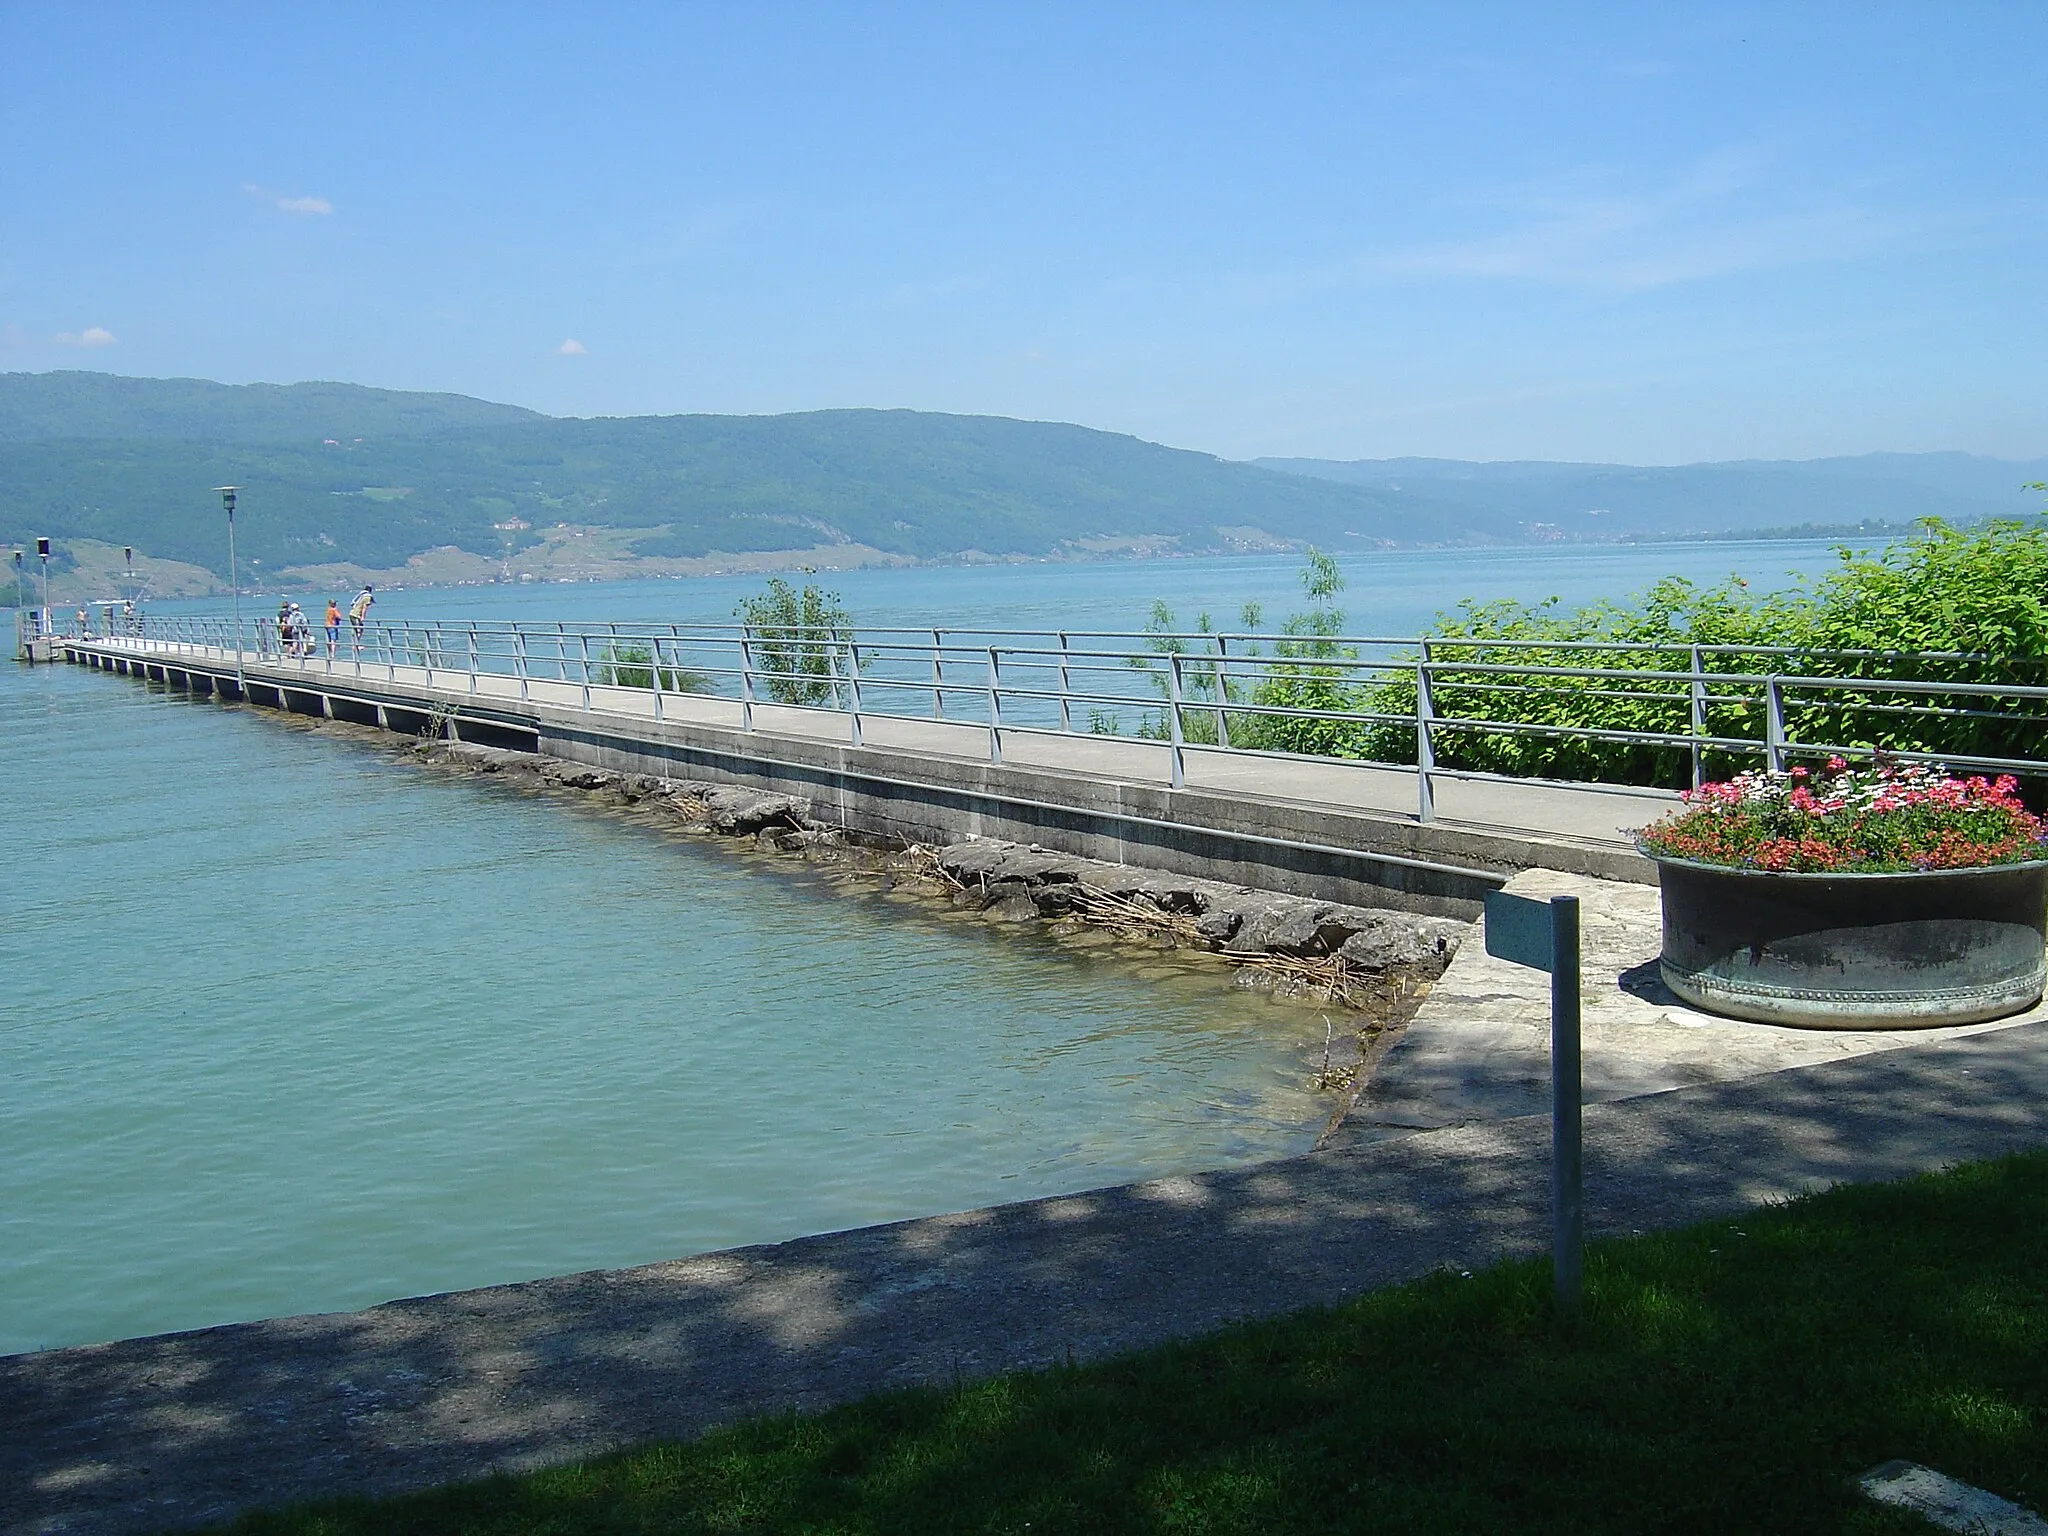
[66,637,1673,918]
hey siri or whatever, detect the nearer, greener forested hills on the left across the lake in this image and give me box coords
[0,373,1462,571]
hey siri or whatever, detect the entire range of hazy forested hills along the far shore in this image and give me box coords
[0,373,2048,584]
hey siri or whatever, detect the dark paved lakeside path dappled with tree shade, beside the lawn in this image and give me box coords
[0,1024,2048,1536]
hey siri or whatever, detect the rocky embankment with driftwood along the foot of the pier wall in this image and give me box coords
[420,741,1468,1006]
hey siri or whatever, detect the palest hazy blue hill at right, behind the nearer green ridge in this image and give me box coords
[1255,453,2048,541]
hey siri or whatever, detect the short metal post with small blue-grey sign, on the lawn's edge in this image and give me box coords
[1487,891,1585,1317]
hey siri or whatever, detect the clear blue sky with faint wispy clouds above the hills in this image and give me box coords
[0,0,2048,463]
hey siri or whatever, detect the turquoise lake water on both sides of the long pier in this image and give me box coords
[0,543,1859,1352]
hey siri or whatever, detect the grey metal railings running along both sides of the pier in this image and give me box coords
[59,616,2048,821]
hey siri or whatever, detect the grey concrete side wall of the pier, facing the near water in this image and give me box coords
[68,645,1655,918]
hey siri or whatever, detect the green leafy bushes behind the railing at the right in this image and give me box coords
[1139,520,2048,786]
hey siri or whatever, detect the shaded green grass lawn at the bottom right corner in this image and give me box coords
[211,1153,2048,1536]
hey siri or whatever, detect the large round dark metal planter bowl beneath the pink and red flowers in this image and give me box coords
[1642,848,2048,1030]
